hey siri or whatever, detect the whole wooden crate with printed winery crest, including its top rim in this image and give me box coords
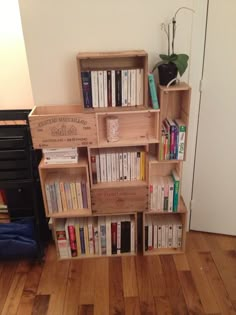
[29,105,97,149]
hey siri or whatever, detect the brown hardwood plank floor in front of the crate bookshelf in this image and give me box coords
[0,232,236,315]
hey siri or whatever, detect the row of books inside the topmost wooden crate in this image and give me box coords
[81,69,144,108]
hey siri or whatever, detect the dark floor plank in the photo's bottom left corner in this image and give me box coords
[0,261,18,314]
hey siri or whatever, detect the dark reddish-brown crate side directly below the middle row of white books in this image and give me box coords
[91,186,148,214]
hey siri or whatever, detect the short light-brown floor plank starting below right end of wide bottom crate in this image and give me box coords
[121,256,138,297]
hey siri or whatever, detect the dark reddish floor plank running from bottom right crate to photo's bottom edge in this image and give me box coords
[161,256,188,315]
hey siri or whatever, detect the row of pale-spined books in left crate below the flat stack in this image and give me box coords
[45,173,88,213]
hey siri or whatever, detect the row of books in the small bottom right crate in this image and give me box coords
[145,215,183,251]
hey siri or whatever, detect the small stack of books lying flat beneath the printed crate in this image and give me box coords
[43,148,79,164]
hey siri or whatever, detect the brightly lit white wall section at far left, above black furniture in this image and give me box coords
[0,0,33,109]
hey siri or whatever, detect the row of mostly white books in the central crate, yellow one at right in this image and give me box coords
[91,147,146,184]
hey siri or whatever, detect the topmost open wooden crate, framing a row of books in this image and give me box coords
[77,50,148,111]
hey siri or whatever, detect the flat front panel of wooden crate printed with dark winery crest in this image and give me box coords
[29,113,97,149]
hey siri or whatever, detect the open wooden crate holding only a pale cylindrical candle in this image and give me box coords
[96,110,160,147]
